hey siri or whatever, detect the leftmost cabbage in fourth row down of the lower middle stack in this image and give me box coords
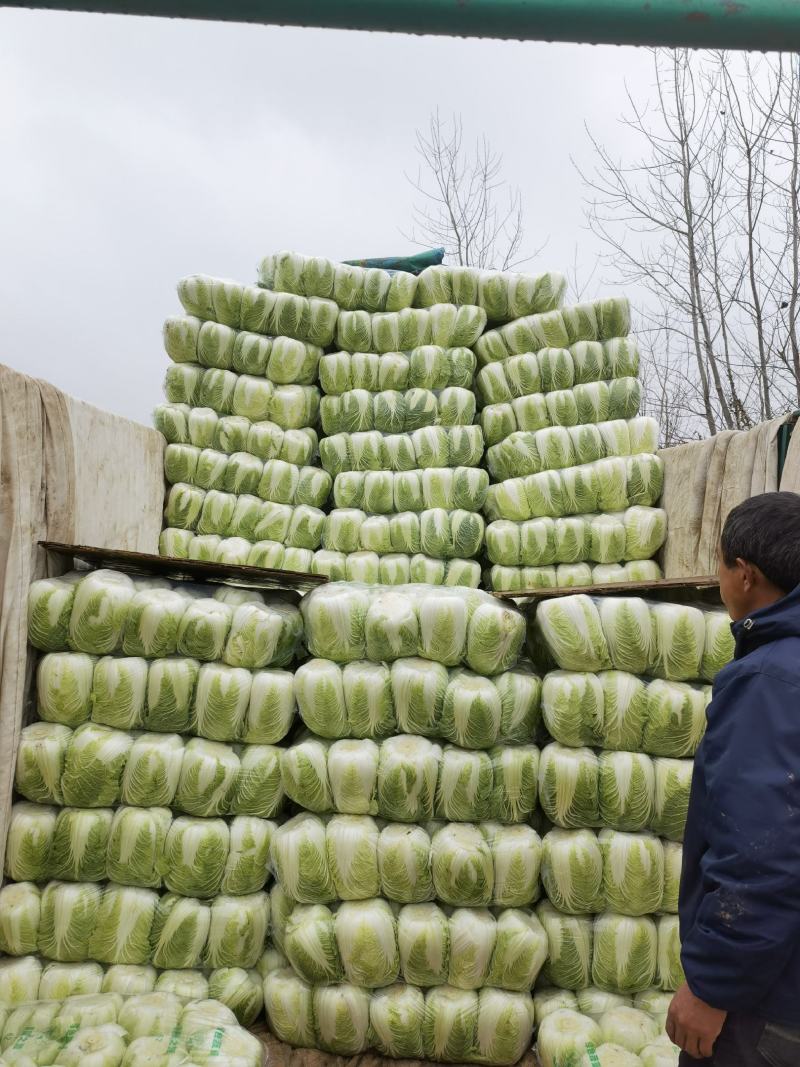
[272,812,336,904]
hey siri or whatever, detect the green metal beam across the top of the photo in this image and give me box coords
[0,0,800,51]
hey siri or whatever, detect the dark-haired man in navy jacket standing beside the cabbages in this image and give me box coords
[667,493,800,1067]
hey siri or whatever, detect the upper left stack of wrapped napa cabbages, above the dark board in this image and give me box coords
[155,275,338,571]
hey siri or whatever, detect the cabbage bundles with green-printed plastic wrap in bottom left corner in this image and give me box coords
[0,990,265,1067]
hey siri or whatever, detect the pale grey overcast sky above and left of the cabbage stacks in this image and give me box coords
[0,9,652,423]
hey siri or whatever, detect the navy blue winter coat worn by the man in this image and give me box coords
[679,586,800,1025]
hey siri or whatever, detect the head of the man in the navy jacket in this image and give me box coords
[719,493,800,622]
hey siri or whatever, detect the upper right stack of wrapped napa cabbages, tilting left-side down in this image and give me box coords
[476,300,667,591]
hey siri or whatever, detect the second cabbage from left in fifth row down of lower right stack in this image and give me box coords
[592,911,658,993]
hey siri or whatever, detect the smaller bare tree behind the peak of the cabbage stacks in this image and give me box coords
[404,111,529,270]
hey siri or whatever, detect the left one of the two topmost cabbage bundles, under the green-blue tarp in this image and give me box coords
[258,252,418,312]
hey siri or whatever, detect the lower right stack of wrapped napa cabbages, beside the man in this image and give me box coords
[520,594,733,1011]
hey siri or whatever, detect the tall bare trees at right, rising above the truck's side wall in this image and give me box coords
[582,50,800,439]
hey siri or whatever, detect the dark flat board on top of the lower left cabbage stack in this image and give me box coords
[39,541,329,592]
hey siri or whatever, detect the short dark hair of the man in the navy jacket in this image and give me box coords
[720,493,800,593]
